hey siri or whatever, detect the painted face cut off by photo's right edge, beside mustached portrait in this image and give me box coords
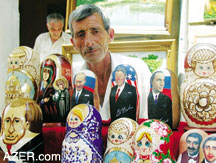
[203,140,216,162]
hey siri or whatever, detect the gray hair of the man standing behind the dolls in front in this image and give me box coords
[68,4,110,37]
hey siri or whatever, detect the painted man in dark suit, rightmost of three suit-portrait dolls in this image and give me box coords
[148,71,172,128]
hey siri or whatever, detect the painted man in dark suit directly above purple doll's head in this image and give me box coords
[71,72,94,108]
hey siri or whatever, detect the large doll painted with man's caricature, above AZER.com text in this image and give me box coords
[0,98,44,162]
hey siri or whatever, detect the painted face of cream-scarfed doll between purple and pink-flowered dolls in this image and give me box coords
[109,131,127,145]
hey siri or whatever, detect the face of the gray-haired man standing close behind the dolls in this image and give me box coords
[72,13,113,63]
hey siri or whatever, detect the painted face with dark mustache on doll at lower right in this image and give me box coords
[186,137,200,156]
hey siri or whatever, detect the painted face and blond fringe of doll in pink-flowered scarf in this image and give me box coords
[135,132,153,156]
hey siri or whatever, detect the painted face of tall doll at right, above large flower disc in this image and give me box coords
[194,62,215,77]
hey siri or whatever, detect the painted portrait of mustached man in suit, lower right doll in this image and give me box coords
[177,132,203,163]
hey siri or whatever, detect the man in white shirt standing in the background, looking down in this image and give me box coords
[34,13,71,61]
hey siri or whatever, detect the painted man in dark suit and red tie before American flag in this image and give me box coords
[110,67,137,122]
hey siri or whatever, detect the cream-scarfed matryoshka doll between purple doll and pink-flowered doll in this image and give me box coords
[104,118,138,163]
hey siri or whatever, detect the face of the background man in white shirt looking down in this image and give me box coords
[47,20,63,40]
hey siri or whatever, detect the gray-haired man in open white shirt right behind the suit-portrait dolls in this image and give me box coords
[69,5,150,123]
